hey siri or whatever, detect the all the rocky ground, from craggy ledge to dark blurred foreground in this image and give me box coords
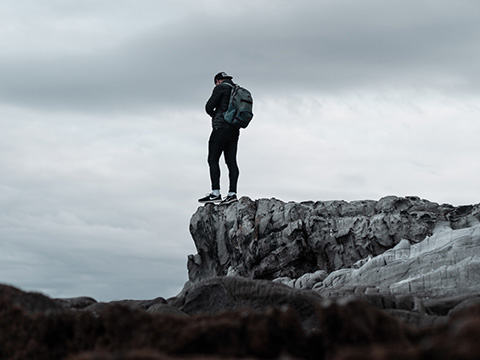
[0,196,480,360]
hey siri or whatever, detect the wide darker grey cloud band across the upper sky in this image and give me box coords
[0,1,480,110]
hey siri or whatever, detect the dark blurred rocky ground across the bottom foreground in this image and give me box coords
[0,279,480,360]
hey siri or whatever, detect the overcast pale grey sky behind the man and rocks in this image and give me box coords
[0,0,480,301]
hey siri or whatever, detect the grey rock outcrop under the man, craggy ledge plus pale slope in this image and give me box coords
[188,196,480,326]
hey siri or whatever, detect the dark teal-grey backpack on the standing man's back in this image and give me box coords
[223,83,253,129]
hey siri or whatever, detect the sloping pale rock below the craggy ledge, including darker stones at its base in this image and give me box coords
[314,225,480,326]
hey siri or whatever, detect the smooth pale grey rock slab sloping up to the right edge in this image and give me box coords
[315,224,480,298]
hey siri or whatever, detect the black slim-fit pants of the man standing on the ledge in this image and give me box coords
[208,128,240,193]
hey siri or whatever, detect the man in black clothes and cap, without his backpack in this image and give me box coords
[198,72,240,205]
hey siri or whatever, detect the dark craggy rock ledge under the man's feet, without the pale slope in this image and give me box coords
[188,196,480,282]
